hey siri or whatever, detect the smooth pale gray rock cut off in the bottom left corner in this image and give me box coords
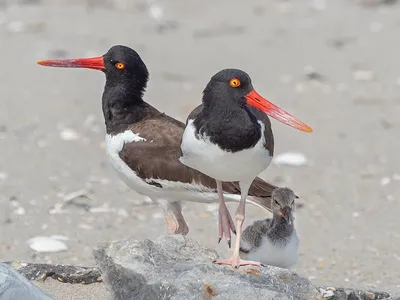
[0,263,52,300]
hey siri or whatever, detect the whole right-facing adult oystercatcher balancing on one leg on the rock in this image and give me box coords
[180,69,312,267]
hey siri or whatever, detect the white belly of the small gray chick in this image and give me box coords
[246,233,299,268]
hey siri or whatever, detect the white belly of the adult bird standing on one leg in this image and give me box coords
[180,120,272,182]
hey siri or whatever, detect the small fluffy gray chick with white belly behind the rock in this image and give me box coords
[240,188,299,268]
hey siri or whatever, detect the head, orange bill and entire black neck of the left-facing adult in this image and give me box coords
[38,46,153,133]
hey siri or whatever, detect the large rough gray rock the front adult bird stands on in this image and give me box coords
[94,236,323,300]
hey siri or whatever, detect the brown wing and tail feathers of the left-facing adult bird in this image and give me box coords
[120,112,276,210]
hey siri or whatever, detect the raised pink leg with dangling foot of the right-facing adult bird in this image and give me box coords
[216,180,236,248]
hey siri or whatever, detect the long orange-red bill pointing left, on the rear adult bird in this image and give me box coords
[38,56,106,70]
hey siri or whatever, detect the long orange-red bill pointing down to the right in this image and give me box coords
[245,90,313,132]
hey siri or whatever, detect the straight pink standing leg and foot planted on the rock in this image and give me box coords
[214,182,261,268]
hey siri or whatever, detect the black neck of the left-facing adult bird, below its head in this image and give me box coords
[102,81,148,134]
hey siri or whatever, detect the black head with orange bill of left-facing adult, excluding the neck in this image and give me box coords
[38,45,149,96]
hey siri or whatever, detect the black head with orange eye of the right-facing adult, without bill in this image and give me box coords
[203,69,253,106]
